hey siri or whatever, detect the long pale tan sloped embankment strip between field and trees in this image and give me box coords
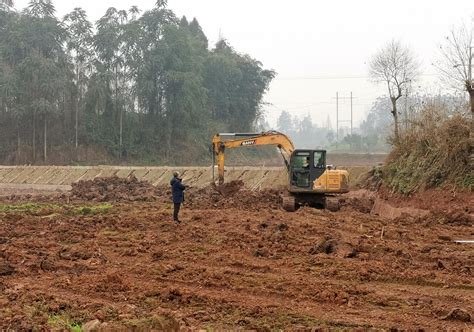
[0,166,369,190]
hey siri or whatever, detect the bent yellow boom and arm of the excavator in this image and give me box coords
[212,131,295,184]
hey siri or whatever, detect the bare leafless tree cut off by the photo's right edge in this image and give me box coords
[436,18,474,165]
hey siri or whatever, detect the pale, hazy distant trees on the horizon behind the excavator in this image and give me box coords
[277,91,467,153]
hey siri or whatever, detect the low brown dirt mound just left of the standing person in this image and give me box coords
[71,175,156,202]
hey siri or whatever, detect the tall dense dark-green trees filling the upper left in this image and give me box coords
[0,0,275,164]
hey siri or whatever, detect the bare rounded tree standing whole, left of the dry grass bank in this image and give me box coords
[369,40,420,144]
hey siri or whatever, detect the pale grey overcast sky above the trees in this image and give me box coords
[15,0,474,126]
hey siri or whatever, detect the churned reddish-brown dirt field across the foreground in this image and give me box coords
[0,183,474,330]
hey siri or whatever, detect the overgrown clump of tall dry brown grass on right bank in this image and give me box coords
[383,106,474,195]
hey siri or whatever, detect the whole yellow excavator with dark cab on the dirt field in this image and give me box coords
[212,131,349,211]
